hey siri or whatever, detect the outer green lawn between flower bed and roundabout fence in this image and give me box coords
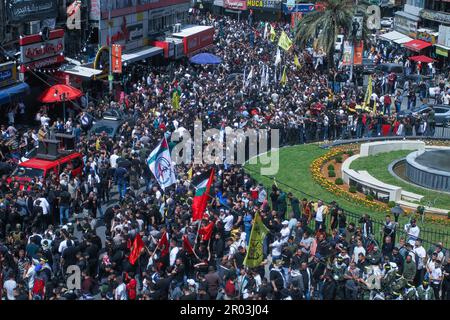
[245,144,450,247]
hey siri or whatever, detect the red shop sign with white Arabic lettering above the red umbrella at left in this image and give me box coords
[19,29,64,67]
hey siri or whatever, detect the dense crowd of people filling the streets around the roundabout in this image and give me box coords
[0,11,450,300]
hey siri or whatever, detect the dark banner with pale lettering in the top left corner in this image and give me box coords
[6,0,58,22]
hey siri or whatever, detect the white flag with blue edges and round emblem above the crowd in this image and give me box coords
[147,137,177,190]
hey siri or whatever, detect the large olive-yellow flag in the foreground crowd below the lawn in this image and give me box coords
[244,212,269,268]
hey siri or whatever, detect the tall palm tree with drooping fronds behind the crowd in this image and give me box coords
[295,0,367,68]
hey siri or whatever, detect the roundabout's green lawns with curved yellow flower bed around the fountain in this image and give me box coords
[245,141,450,246]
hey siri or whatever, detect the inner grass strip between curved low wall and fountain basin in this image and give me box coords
[350,150,450,211]
